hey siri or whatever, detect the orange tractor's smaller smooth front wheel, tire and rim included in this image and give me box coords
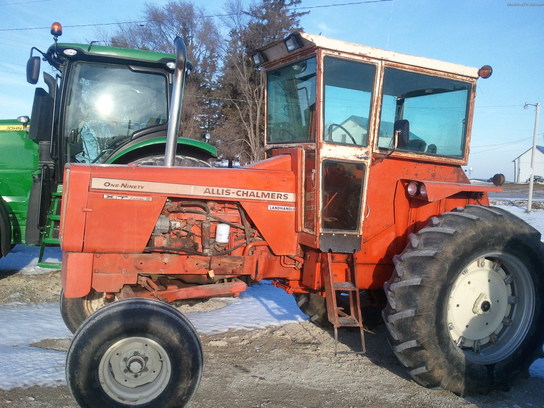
[66,299,203,408]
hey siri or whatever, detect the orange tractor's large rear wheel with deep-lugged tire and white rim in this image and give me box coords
[383,206,544,395]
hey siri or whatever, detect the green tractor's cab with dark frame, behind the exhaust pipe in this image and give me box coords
[27,23,175,174]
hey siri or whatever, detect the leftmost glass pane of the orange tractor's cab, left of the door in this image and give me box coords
[267,58,315,143]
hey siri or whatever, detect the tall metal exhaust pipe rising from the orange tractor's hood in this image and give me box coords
[164,37,187,167]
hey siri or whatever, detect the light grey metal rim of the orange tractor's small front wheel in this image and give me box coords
[98,337,172,405]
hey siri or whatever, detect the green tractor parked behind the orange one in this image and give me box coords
[0,23,217,266]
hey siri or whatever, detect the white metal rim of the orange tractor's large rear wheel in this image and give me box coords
[447,253,536,364]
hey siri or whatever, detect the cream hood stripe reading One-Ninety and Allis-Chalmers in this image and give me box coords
[91,177,295,202]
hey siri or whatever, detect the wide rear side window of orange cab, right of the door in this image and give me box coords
[378,68,471,158]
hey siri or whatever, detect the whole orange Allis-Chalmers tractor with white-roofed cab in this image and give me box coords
[61,32,544,407]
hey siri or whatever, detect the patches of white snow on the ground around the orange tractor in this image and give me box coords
[0,206,544,389]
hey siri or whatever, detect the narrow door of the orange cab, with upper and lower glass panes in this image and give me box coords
[316,55,377,253]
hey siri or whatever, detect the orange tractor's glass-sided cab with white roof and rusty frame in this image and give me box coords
[253,32,490,252]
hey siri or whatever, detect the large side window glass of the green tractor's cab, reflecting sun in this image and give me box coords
[65,63,168,163]
